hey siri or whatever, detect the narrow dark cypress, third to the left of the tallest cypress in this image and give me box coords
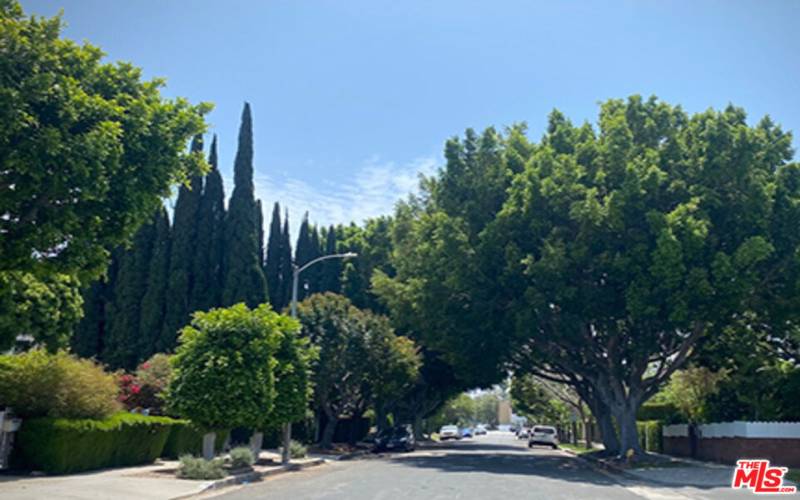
[139,206,173,359]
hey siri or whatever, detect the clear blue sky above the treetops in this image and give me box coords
[22,0,800,228]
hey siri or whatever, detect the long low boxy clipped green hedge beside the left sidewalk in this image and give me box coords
[14,413,175,474]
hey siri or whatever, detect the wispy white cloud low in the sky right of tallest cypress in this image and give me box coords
[226,157,436,236]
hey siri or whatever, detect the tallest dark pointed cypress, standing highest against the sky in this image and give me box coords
[222,103,267,307]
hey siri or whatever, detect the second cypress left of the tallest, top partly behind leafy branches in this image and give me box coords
[161,135,203,350]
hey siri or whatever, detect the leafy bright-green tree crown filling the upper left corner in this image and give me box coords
[0,0,209,288]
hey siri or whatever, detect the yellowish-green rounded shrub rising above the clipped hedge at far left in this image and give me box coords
[0,349,120,419]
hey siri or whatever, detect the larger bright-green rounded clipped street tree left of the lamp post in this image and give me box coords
[167,304,284,458]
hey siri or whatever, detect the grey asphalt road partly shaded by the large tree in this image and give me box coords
[209,433,752,500]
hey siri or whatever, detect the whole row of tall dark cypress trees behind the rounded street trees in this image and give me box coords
[72,104,342,369]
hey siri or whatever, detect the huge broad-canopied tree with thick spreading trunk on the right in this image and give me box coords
[382,96,800,458]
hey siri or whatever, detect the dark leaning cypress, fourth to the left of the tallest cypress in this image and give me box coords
[102,213,156,369]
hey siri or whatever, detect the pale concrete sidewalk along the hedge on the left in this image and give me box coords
[0,452,326,500]
